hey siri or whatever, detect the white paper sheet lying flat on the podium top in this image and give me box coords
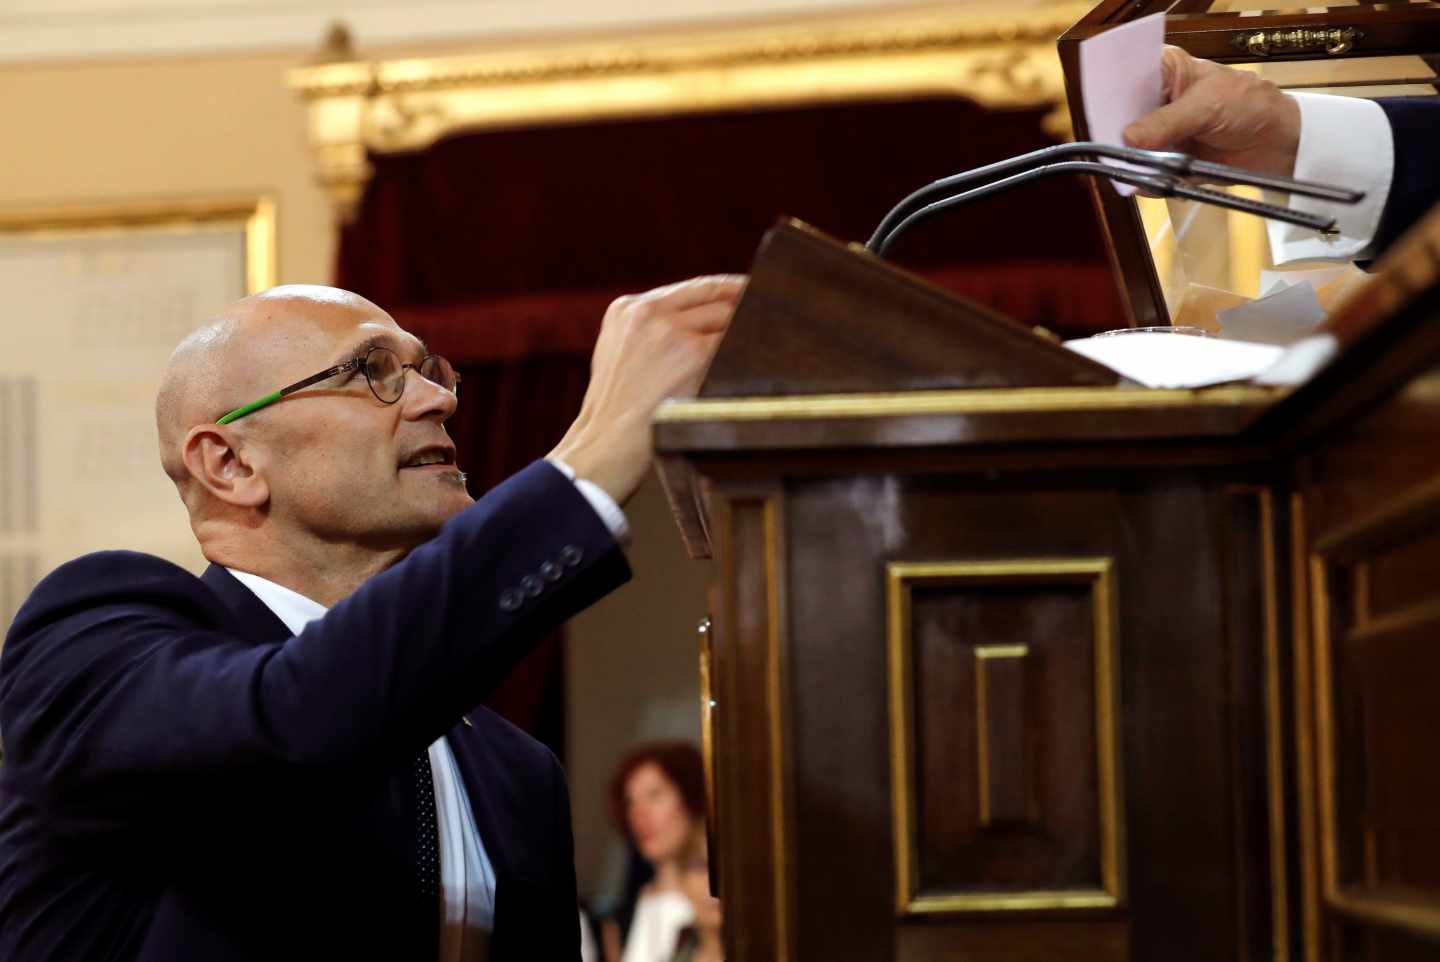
[1064,331,1284,387]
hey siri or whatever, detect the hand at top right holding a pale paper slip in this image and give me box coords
[1125,46,1300,177]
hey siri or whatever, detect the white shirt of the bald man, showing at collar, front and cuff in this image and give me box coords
[226,459,629,962]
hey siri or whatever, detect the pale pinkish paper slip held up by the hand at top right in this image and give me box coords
[1080,13,1165,196]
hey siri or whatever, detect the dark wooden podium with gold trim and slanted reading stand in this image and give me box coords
[655,219,1440,962]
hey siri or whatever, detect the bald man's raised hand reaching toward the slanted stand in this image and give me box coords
[550,275,746,504]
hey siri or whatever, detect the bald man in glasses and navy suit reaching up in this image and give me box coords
[0,277,742,962]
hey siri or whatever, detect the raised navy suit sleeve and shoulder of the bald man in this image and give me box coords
[0,462,629,831]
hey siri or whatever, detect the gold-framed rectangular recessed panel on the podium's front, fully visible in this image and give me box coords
[888,559,1120,913]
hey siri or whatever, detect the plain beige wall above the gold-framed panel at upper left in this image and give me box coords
[0,55,333,281]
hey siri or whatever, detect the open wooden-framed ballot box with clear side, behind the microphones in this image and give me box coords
[1060,0,1440,327]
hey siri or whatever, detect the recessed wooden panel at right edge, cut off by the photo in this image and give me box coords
[1312,478,1440,958]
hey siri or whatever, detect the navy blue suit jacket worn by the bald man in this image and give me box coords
[0,462,629,962]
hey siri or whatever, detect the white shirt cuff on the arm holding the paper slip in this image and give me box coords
[1266,94,1395,266]
